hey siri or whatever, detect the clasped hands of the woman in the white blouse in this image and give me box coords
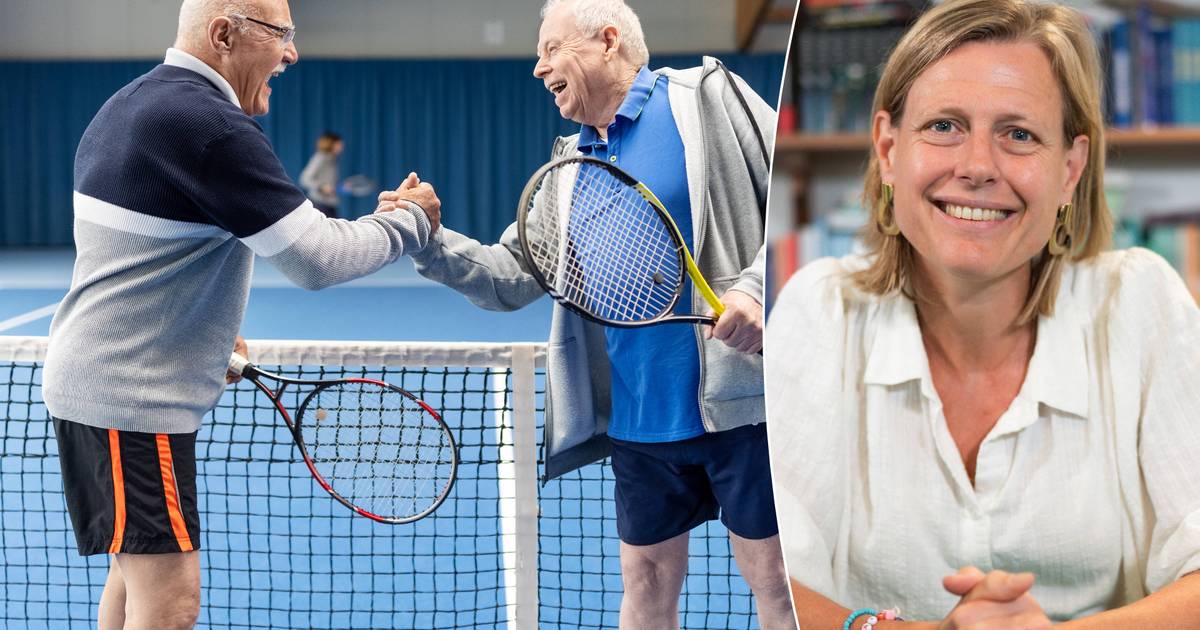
[938,566,1052,630]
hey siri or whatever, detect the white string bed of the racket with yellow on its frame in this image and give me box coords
[526,163,684,322]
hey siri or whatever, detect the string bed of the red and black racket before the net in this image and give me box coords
[300,383,454,518]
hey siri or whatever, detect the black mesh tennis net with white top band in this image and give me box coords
[0,337,757,629]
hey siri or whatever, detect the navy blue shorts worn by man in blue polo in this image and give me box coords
[612,422,779,545]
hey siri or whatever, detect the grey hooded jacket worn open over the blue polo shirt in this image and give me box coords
[413,58,776,480]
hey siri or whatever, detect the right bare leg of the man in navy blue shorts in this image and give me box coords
[730,532,796,630]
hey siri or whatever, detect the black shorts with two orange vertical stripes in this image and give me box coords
[54,418,200,556]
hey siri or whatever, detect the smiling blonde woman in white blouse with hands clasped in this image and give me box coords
[766,0,1200,630]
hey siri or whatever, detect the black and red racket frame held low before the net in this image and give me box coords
[229,353,458,524]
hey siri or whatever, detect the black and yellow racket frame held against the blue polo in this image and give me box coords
[517,155,725,328]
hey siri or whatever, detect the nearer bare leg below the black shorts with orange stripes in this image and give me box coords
[115,551,200,630]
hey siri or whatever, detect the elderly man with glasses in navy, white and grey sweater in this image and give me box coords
[43,0,440,630]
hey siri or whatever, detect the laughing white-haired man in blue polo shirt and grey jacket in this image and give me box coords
[400,0,793,630]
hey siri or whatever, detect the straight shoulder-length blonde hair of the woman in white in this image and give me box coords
[853,0,1112,323]
